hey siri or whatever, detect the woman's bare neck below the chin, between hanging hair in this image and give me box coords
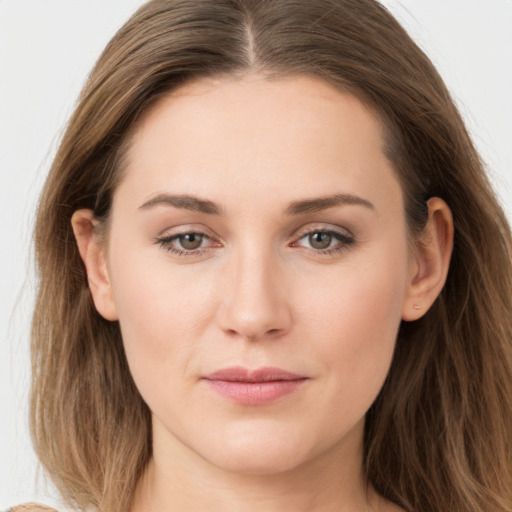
[131,418,384,512]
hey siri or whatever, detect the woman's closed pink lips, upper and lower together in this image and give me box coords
[202,366,308,405]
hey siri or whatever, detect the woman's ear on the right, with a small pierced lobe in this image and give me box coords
[402,197,453,321]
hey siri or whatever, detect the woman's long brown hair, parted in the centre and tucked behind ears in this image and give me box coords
[31,0,512,512]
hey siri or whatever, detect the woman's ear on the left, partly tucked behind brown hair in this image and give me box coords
[71,209,118,321]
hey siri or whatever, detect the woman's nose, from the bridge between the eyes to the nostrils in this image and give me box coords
[218,246,292,341]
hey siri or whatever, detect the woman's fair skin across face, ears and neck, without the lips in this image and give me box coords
[73,75,452,512]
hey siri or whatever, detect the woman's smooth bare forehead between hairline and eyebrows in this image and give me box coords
[120,75,398,213]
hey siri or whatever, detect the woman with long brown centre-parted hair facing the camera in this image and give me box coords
[8,0,512,512]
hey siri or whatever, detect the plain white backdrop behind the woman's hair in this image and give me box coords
[0,0,512,510]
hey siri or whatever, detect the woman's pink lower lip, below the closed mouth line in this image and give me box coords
[205,379,307,405]
